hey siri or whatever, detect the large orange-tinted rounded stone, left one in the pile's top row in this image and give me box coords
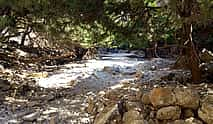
[150,88,176,107]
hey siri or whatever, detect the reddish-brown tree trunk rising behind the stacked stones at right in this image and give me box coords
[178,0,201,83]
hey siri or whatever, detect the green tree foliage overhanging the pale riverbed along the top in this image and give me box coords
[0,0,213,48]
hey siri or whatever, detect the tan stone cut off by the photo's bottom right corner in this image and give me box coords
[198,102,213,124]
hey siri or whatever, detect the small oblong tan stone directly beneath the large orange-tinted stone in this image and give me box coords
[156,106,181,120]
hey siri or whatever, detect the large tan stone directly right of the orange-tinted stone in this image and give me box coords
[174,88,200,110]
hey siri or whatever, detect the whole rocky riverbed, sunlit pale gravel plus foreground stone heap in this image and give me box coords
[0,50,213,124]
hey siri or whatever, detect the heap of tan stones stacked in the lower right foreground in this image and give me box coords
[88,86,213,124]
